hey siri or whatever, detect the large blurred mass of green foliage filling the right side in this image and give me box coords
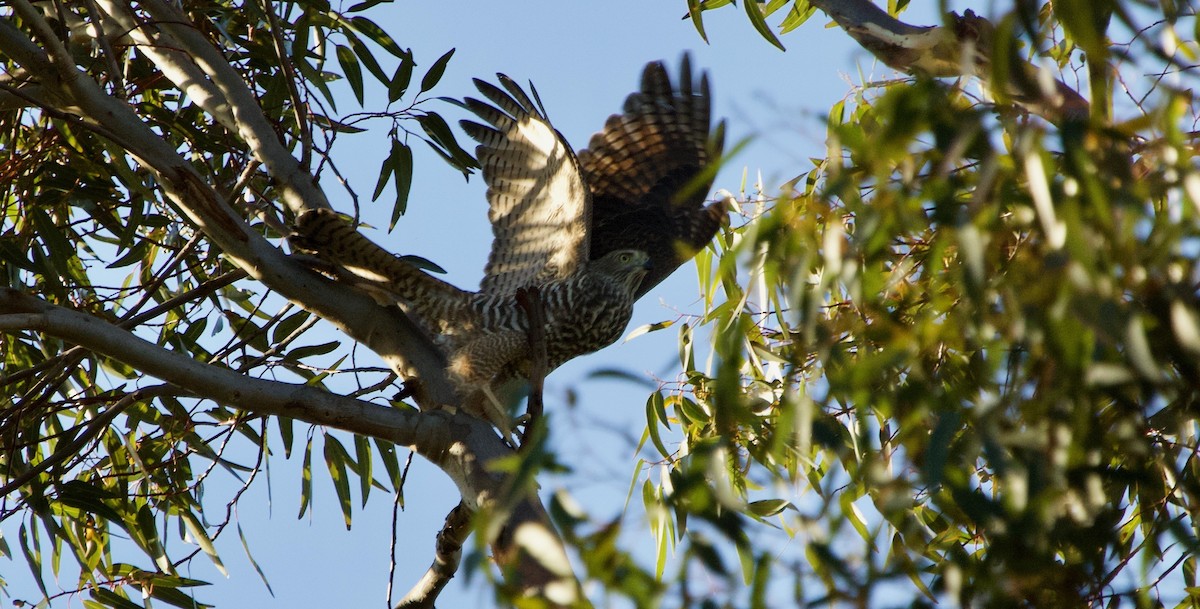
[628,2,1200,607]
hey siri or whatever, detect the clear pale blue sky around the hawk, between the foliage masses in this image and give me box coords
[0,0,950,608]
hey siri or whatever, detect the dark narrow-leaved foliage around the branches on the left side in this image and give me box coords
[0,1,473,607]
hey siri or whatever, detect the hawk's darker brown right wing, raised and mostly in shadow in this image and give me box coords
[578,55,728,296]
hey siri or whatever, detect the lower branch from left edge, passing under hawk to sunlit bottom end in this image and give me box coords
[0,288,581,607]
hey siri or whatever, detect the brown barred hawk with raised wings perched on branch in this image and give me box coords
[290,55,728,432]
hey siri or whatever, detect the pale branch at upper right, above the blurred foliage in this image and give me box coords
[811,0,1090,122]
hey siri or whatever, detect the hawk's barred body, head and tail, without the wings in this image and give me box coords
[292,210,649,386]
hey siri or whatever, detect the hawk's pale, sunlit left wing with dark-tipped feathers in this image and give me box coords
[462,74,590,294]
